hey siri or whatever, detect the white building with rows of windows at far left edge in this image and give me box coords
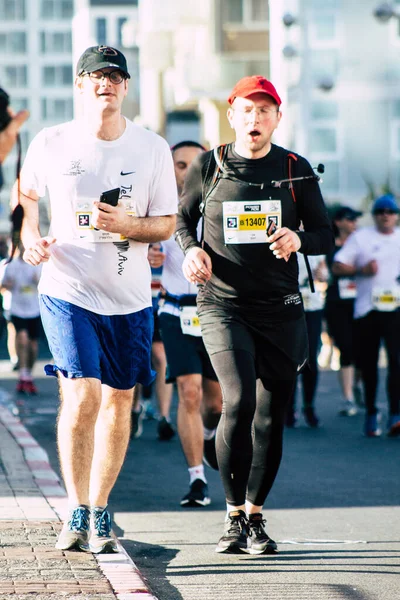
[0,0,74,231]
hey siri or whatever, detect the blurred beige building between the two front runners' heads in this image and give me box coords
[137,0,269,146]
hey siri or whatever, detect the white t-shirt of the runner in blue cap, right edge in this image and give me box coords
[335,227,400,319]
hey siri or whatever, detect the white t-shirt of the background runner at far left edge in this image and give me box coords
[0,257,41,319]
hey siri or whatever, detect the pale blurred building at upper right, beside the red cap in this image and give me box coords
[270,0,400,208]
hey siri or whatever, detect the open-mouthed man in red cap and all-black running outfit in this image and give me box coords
[176,75,334,554]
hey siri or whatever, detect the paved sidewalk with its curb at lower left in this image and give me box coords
[0,364,157,600]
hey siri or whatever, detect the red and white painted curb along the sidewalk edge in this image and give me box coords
[0,390,158,600]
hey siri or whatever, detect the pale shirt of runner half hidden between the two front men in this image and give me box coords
[158,236,198,317]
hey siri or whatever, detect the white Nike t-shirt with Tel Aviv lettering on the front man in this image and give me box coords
[21,120,177,315]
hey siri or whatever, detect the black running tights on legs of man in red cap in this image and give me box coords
[211,350,294,506]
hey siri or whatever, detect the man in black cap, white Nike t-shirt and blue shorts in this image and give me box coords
[16,46,177,553]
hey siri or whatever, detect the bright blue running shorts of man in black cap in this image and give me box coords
[39,294,155,390]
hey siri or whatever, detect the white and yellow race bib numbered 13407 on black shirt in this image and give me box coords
[222,200,282,244]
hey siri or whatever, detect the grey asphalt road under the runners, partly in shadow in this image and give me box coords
[0,356,400,600]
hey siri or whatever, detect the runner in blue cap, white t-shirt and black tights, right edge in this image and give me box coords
[332,194,400,437]
